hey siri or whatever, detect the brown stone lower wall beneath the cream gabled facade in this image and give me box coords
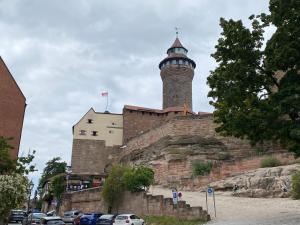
[71,139,120,175]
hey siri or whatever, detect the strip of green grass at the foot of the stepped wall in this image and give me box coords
[144,216,205,225]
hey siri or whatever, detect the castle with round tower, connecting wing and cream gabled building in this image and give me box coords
[71,37,196,178]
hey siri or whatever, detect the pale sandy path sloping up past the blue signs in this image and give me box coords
[149,186,300,225]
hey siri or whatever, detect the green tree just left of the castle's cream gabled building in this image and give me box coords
[39,157,67,189]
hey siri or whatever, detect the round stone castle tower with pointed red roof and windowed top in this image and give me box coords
[159,37,196,111]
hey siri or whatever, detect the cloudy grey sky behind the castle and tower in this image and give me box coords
[0,0,268,186]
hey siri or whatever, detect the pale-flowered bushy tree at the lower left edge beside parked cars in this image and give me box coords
[0,174,28,225]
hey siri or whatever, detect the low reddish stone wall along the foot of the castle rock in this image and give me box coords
[150,153,294,190]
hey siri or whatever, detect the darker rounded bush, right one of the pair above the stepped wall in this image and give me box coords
[124,167,154,192]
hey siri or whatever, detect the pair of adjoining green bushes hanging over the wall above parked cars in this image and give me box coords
[102,165,154,211]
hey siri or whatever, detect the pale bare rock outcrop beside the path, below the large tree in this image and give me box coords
[210,164,300,198]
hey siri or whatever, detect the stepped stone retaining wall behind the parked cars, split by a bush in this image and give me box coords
[60,188,210,221]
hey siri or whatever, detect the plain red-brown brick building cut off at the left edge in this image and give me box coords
[0,57,26,158]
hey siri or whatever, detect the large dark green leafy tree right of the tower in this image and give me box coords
[207,0,300,156]
